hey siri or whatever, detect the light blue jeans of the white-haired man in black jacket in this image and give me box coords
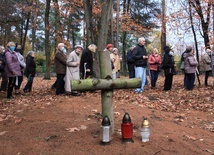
[135,67,146,91]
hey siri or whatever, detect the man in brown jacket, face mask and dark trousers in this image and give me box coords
[54,43,67,95]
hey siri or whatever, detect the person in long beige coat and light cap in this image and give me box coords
[64,45,83,96]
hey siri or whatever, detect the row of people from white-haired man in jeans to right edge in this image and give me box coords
[126,37,214,93]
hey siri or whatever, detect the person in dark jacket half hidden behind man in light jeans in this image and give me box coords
[126,46,135,78]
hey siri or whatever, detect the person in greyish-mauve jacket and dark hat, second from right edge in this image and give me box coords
[184,46,198,90]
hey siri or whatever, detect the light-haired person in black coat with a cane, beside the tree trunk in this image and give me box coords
[80,44,97,79]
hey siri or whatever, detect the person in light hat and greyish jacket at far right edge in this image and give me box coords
[201,49,212,86]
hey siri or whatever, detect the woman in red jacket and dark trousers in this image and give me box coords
[148,48,161,89]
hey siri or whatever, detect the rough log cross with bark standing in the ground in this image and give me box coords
[71,51,141,134]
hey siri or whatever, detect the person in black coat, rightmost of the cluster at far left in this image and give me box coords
[23,51,36,93]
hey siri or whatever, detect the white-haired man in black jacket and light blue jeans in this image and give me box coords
[132,37,148,93]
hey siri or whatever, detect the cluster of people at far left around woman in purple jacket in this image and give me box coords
[0,41,36,99]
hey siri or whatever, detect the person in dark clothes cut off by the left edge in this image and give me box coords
[0,46,8,91]
